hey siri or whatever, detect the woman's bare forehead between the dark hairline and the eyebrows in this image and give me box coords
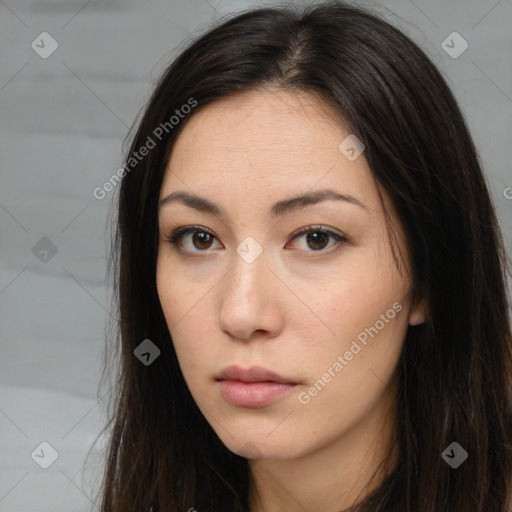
[160,90,376,214]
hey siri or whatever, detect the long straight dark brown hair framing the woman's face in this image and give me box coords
[92,2,512,512]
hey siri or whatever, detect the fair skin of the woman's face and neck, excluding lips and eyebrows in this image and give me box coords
[157,89,424,512]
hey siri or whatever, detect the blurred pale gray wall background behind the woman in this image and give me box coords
[0,0,512,512]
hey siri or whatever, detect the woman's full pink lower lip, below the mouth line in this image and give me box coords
[219,380,296,408]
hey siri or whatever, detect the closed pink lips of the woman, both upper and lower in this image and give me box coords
[216,366,297,408]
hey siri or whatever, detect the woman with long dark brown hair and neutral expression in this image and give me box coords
[94,2,512,512]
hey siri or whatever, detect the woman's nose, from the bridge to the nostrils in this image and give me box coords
[219,247,285,341]
